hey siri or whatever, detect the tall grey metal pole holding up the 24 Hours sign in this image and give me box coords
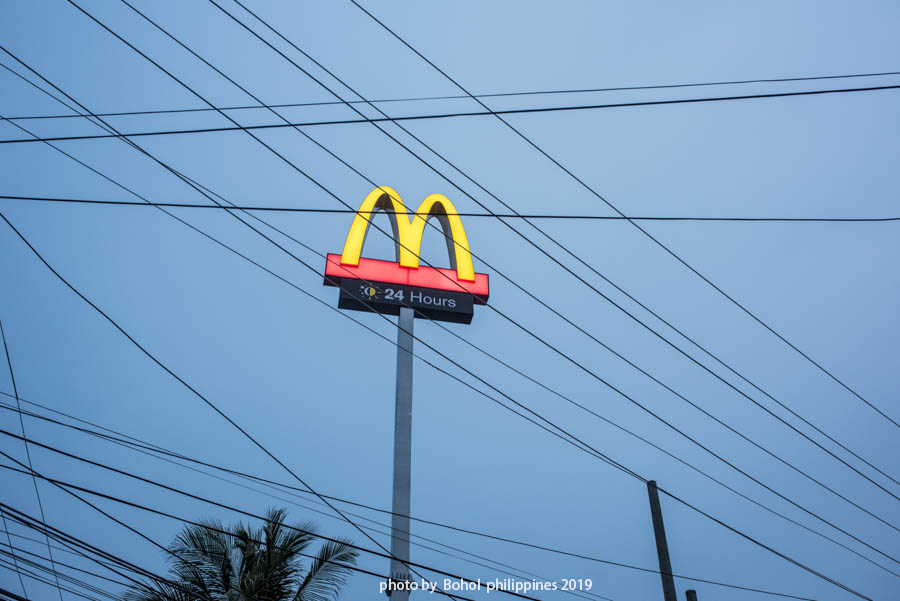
[391,307,414,601]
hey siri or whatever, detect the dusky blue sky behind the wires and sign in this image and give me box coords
[0,0,900,601]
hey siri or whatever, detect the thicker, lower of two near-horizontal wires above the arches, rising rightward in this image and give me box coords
[0,85,900,144]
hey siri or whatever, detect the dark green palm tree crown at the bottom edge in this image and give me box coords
[125,509,358,601]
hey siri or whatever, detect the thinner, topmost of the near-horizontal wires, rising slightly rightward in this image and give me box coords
[0,65,900,121]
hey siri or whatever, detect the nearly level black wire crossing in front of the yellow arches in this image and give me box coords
[0,193,900,223]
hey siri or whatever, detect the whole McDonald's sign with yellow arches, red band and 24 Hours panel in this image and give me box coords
[325,186,488,323]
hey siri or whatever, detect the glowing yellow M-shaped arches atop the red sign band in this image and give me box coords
[341,186,475,282]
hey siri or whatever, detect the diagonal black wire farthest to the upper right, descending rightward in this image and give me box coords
[344,0,900,428]
